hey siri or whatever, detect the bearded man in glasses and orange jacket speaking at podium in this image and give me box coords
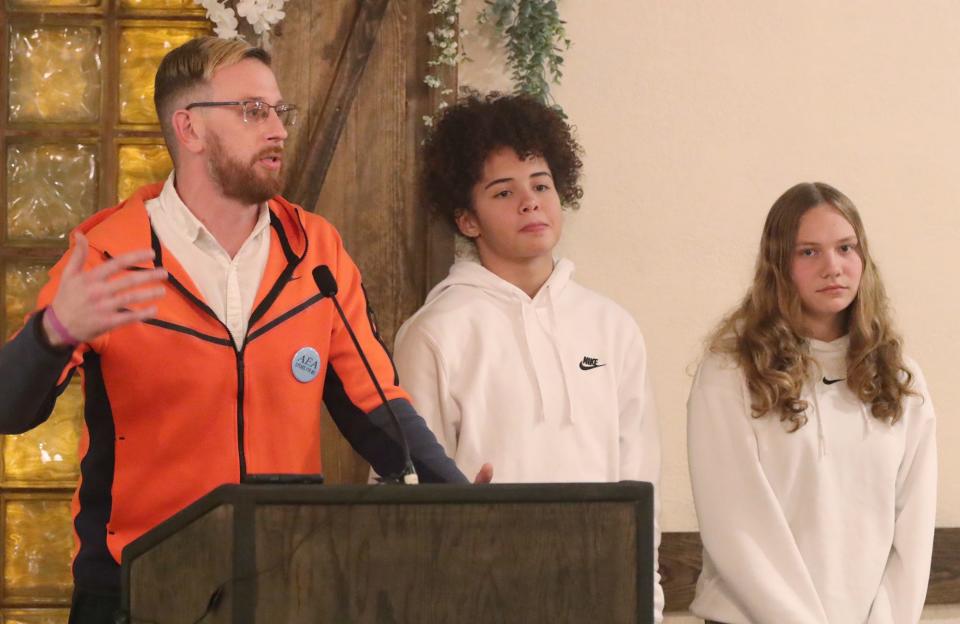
[0,37,491,622]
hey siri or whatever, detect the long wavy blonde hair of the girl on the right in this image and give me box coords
[708,182,914,431]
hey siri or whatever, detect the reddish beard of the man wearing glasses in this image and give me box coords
[208,134,286,204]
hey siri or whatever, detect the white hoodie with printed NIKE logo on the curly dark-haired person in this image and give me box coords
[394,260,663,621]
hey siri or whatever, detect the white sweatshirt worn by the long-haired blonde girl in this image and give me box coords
[687,337,937,624]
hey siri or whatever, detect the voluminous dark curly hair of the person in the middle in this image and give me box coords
[420,92,583,234]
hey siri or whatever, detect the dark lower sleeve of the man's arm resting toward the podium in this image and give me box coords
[323,366,470,483]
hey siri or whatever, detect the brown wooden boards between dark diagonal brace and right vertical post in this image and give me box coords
[316,1,414,344]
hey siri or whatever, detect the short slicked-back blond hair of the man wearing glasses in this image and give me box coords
[153,37,271,160]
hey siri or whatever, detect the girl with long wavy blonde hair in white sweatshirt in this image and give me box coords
[687,183,937,624]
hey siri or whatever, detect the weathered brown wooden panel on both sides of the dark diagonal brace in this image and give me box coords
[273,0,453,483]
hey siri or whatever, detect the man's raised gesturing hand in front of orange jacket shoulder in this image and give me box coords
[43,233,167,347]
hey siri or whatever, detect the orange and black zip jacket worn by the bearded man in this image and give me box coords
[0,184,466,592]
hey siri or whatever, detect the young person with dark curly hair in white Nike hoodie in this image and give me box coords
[372,94,663,621]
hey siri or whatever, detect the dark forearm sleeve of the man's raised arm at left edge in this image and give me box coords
[0,312,72,433]
